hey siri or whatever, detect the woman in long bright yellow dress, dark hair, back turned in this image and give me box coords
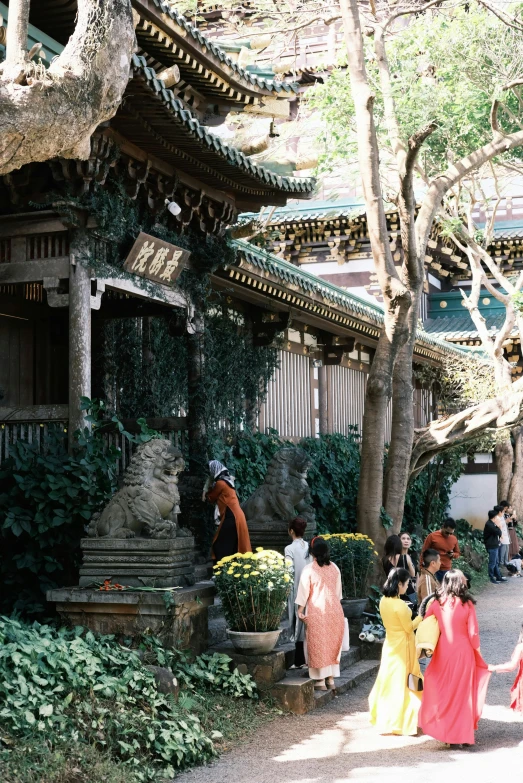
[369,568,421,735]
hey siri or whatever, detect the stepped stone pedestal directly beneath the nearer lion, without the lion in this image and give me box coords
[80,536,196,587]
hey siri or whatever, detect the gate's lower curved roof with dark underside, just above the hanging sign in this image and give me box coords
[116,55,315,203]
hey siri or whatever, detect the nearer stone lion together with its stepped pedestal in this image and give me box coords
[80,439,195,587]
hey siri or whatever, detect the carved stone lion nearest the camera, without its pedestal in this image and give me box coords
[87,439,185,538]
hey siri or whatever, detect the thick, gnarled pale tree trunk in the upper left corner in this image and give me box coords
[0,0,136,175]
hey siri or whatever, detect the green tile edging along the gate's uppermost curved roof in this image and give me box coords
[144,0,298,96]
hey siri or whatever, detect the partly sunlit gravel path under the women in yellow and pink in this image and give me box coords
[176,579,523,783]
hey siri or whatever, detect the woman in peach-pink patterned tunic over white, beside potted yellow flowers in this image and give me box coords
[296,538,344,690]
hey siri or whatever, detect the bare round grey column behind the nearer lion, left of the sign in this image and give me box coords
[69,229,91,450]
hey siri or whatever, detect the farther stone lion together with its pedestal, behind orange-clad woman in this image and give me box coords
[242,448,316,553]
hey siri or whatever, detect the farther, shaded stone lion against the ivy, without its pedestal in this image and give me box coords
[242,448,314,524]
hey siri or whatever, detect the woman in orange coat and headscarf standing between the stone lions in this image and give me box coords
[206,459,252,561]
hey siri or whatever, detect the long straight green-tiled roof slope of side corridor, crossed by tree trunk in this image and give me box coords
[234,239,477,355]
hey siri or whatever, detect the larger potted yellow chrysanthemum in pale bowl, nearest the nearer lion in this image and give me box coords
[214,547,293,655]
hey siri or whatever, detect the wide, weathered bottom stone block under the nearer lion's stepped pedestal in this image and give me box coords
[47,582,215,655]
